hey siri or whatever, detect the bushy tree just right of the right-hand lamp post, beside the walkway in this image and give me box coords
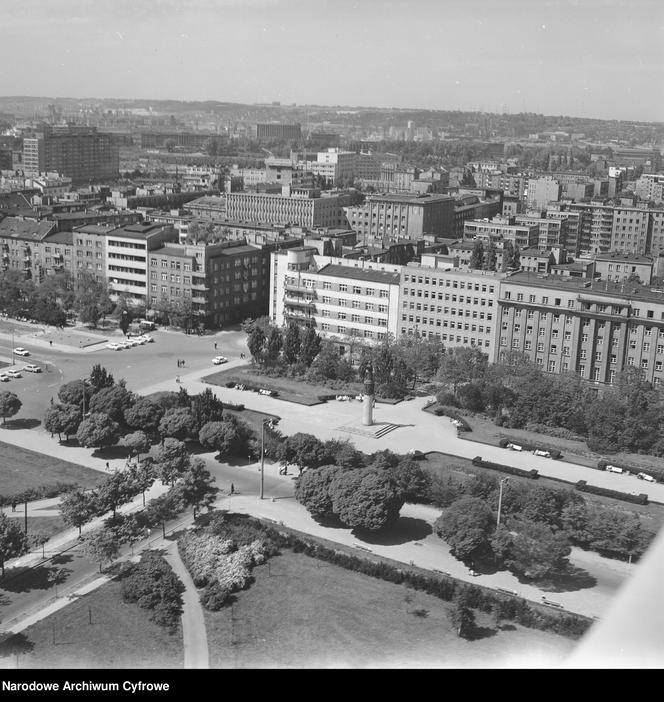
[502,519,571,580]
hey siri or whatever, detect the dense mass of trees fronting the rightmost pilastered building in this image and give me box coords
[436,347,664,456]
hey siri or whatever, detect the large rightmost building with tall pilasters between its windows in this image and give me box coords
[494,272,664,385]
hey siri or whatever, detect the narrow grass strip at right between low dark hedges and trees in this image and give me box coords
[420,453,664,532]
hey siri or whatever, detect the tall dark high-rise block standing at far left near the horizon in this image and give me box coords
[23,125,120,185]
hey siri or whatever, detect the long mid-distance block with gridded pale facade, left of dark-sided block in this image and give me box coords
[226,189,361,228]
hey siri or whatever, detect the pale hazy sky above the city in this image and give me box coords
[0,0,664,121]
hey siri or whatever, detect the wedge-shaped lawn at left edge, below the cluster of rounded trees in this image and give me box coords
[0,441,104,504]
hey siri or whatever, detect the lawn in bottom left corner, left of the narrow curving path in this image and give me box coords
[0,581,184,669]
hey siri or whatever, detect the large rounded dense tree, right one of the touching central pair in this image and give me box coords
[330,468,404,531]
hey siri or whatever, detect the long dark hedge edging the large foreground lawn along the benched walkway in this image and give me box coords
[236,518,592,638]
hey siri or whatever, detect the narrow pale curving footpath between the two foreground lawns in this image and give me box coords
[164,542,210,669]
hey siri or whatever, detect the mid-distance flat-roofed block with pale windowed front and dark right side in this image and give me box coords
[346,194,454,242]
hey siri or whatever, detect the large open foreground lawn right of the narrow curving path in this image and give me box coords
[205,551,574,668]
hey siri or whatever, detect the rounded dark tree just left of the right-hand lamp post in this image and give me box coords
[433,497,496,561]
